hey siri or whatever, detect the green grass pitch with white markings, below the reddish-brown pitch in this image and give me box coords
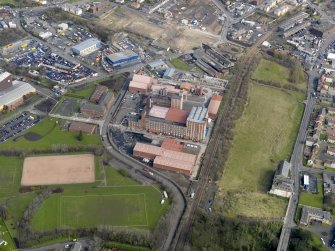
[32,185,167,231]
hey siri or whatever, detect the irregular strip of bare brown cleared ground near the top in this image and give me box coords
[100,8,219,51]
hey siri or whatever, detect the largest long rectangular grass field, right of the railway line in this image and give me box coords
[216,84,303,217]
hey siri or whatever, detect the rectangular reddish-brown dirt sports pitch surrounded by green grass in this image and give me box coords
[21,154,95,186]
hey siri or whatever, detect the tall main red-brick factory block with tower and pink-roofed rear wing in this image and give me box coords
[128,75,210,141]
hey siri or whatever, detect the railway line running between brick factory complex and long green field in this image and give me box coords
[174,30,273,251]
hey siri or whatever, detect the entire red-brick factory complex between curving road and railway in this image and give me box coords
[114,74,222,175]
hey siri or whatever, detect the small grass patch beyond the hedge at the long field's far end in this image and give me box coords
[252,59,307,91]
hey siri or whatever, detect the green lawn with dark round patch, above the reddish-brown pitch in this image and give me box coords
[0,118,101,150]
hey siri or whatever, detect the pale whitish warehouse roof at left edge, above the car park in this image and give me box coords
[0,80,36,108]
